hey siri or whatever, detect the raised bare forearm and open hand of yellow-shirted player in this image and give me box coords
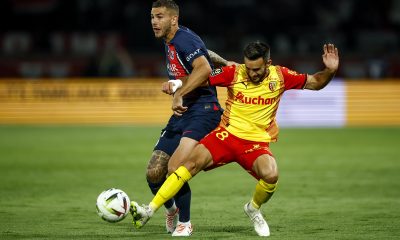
[304,44,339,90]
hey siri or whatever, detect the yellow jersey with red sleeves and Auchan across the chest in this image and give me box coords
[209,64,307,142]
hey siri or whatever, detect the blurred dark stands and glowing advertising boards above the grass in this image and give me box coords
[0,0,400,126]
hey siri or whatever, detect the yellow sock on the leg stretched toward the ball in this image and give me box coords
[149,166,192,211]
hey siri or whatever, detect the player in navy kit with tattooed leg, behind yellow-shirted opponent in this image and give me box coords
[132,0,227,236]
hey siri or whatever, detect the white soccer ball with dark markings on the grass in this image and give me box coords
[96,188,131,222]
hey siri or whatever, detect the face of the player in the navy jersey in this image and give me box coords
[151,7,177,38]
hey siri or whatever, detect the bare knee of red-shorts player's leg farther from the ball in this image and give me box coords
[252,154,279,183]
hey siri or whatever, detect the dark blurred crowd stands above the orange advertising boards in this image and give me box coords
[0,0,400,79]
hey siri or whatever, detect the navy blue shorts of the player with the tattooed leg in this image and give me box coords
[154,103,223,156]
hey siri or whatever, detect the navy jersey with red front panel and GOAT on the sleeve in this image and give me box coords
[165,26,218,106]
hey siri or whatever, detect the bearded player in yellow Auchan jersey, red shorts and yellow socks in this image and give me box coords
[131,42,339,236]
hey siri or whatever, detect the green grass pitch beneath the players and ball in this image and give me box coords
[0,126,400,239]
